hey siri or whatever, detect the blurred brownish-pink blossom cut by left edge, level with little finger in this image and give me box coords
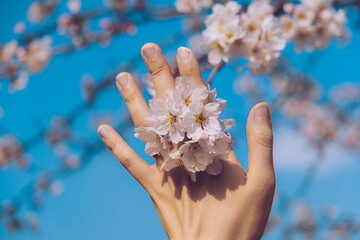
[0,135,28,169]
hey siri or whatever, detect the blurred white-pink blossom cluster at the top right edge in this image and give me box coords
[280,0,347,52]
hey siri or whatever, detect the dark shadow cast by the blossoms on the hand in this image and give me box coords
[162,160,246,202]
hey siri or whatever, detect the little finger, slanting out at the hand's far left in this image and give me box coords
[98,124,153,190]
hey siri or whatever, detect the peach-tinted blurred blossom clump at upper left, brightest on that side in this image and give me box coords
[19,36,52,72]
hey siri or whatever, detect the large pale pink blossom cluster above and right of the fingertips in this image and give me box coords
[203,1,286,75]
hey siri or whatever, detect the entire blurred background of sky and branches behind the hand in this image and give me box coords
[0,0,360,240]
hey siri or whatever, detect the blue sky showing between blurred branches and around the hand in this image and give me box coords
[0,0,360,240]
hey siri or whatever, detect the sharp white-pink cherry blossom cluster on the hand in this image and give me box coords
[135,77,235,181]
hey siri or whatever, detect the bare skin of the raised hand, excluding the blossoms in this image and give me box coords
[98,43,276,240]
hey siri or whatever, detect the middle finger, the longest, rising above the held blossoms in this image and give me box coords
[141,43,175,98]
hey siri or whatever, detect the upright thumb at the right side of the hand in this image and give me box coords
[246,103,275,184]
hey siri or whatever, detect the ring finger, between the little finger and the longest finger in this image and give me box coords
[116,72,150,127]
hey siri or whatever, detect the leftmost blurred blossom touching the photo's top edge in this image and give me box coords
[27,0,59,23]
